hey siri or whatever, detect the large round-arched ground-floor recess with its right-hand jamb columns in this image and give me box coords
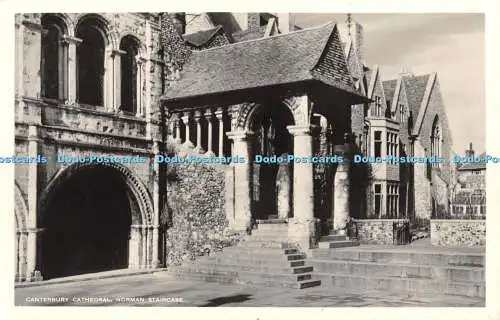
[39,164,153,279]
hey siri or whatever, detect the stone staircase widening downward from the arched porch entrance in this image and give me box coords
[170,219,321,289]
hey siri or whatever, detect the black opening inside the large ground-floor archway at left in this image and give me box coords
[40,167,132,279]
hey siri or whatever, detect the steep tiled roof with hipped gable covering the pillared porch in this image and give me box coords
[164,23,364,100]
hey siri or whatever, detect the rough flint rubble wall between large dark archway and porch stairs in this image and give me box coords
[165,163,244,266]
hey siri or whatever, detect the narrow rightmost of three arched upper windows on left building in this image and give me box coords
[120,36,139,113]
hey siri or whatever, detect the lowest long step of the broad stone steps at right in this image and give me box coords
[314,272,485,298]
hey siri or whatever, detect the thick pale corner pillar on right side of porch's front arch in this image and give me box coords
[287,125,317,250]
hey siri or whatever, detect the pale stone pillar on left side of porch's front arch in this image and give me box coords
[227,131,253,231]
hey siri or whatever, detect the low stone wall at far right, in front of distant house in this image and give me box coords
[431,220,486,247]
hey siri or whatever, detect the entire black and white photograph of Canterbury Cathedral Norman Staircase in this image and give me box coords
[0,4,500,319]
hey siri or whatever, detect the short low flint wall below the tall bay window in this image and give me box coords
[352,219,408,244]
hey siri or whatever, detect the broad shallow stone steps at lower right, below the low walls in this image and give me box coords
[308,246,485,298]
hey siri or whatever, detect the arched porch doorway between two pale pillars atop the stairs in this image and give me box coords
[250,105,294,220]
